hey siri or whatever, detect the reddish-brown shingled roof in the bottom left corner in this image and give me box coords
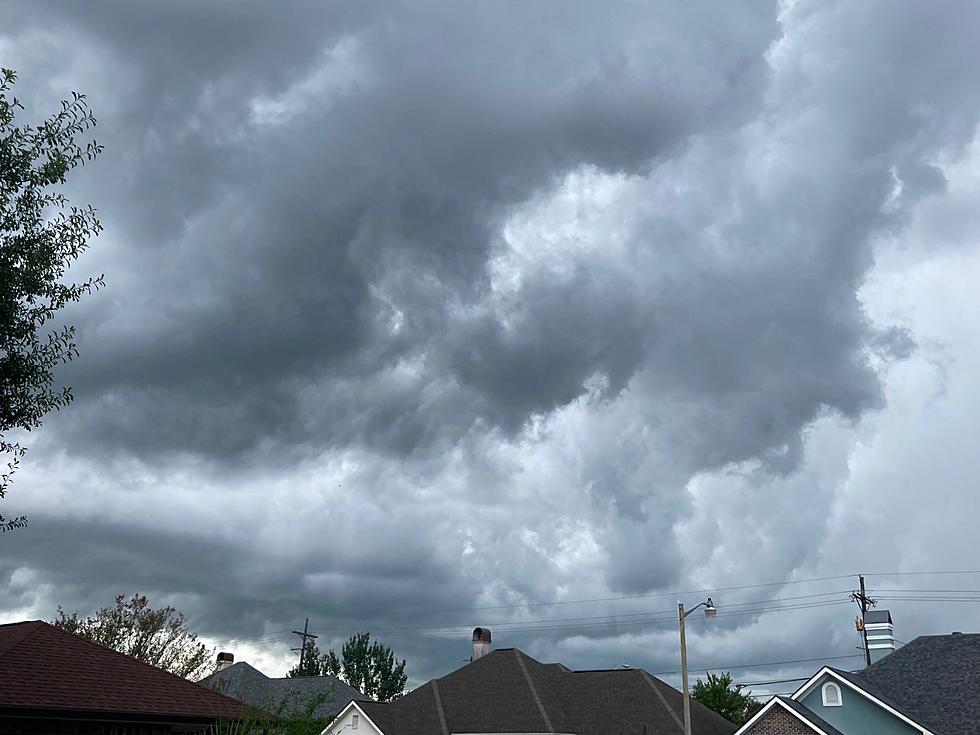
[0,620,245,719]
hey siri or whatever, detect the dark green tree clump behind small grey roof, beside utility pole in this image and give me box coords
[287,633,408,702]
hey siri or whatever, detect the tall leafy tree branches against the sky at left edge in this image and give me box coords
[0,69,102,531]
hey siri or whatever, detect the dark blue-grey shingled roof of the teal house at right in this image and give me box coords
[848,633,980,735]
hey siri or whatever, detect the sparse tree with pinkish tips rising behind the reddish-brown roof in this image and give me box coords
[52,594,214,681]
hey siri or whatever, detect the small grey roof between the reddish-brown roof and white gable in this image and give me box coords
[201,661,364,719]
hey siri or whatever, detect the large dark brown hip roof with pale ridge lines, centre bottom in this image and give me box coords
[334,648,735,735]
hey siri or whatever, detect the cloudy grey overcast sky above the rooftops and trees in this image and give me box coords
[0,0,980,692]
